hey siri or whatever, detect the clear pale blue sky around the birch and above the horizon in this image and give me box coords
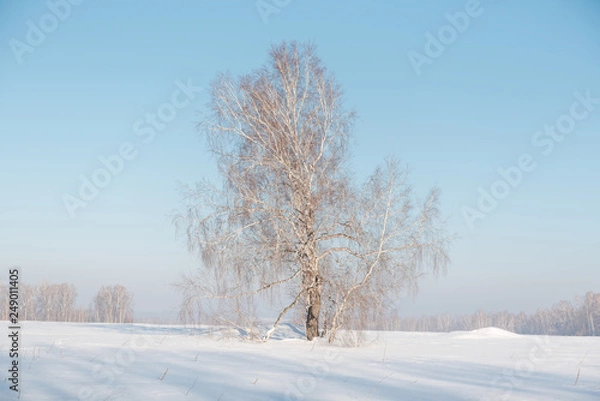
[0,0,600,315]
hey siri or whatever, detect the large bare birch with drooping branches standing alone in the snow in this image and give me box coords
[175,42,448,341]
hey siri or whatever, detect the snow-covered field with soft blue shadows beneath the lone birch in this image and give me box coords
[0,322,600,401]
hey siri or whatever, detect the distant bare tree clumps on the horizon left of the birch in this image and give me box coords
[0,281,133,323]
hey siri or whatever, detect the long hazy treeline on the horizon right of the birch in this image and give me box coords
[378,292,600,336]
